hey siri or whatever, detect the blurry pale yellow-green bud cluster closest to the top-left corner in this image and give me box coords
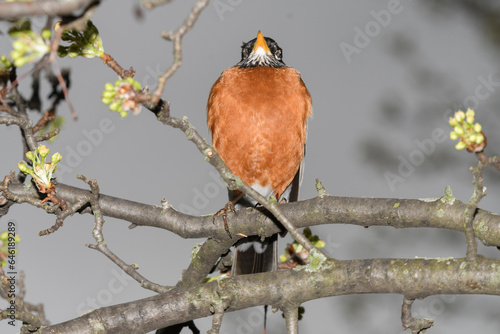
[9,20,52,67]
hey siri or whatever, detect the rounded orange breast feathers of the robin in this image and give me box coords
[207,66,311,198]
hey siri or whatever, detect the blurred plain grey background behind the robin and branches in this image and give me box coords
[0,0,500,334]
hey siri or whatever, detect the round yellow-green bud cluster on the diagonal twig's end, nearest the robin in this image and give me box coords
[101,77,141,117]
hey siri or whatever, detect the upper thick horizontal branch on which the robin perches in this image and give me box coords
[3,184,500,246]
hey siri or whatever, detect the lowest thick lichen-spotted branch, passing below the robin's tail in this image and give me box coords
[41,257,500,334]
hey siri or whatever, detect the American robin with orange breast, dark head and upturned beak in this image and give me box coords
[207,31,311,275]
